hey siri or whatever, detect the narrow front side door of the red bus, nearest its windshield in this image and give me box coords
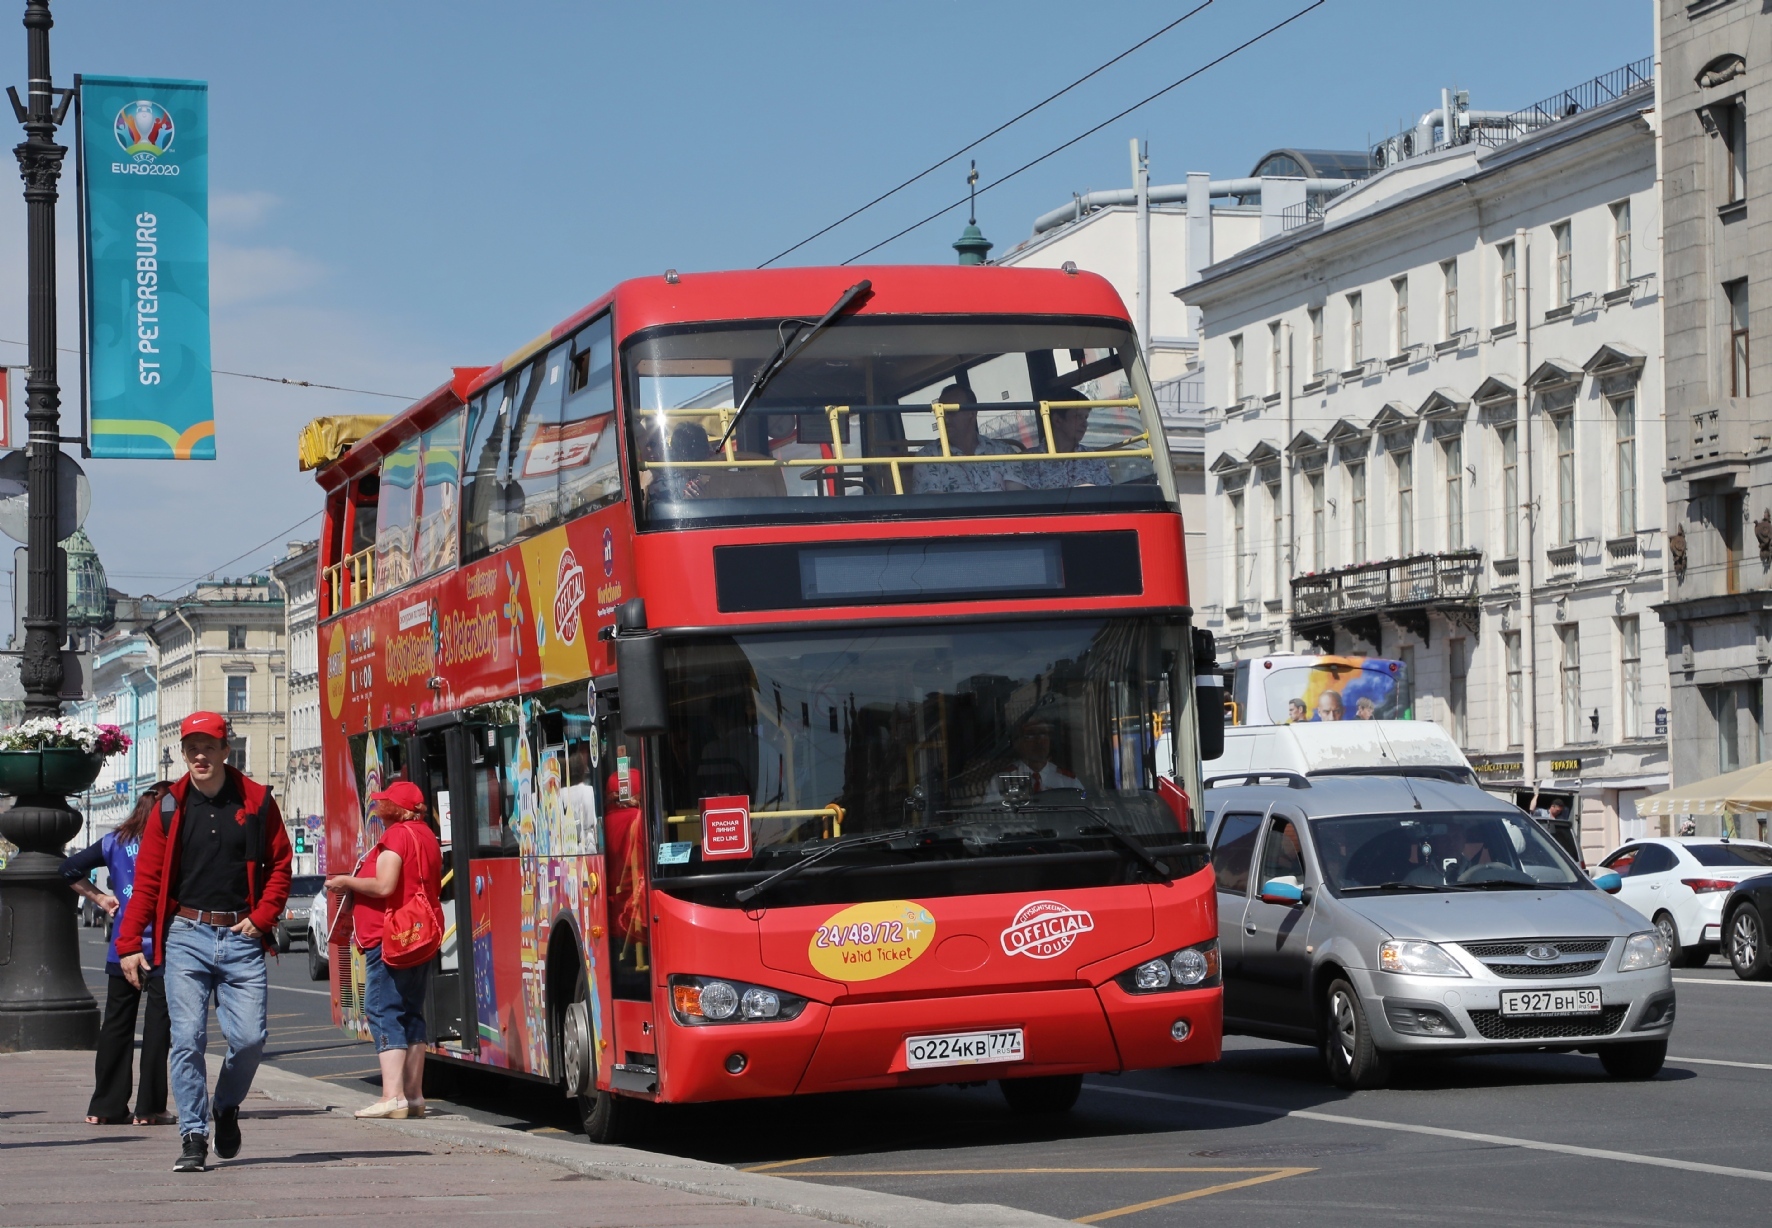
[597,691,657,1095]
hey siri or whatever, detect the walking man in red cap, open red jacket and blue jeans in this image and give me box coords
[117,712,291,1173]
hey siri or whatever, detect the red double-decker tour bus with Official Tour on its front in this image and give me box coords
[303,268,1221,1139]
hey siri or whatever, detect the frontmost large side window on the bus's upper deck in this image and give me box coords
[462,315,622,558]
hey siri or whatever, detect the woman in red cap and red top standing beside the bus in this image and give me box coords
[326,780,443,1118]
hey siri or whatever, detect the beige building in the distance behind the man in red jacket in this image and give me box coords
[147,574,289,797]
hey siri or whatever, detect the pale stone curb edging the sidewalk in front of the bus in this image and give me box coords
[233,1056,1070,1228]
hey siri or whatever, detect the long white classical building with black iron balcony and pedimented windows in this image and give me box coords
[1177,62,1667,852]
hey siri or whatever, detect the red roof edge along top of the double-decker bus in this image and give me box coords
[315,264,1131,491]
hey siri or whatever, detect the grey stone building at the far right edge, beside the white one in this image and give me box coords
[1657,0,1772,793]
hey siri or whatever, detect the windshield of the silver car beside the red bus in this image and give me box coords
[1311,810,1589,895]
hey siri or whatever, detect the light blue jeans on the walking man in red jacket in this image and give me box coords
[167,918,268,1134]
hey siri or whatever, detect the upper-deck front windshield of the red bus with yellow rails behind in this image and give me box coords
[624,315,1175,528]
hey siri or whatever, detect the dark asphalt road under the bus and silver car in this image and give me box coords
[82,930,1772,1228]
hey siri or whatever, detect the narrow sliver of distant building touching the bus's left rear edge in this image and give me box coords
[271,542,326,874]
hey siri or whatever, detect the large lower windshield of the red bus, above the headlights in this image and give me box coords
[659,618,1194,875]
